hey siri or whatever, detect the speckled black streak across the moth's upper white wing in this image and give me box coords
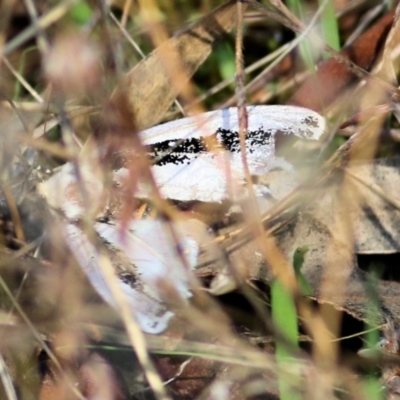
[147,128,276,165]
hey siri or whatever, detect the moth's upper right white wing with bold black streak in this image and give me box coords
[115,105,325,203]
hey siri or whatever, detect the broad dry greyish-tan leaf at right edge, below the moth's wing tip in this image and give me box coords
[280,158,400,320]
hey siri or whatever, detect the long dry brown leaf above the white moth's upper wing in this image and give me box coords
[114,0,244,129]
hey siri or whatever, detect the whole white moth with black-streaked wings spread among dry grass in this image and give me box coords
[38,106,325,333]
